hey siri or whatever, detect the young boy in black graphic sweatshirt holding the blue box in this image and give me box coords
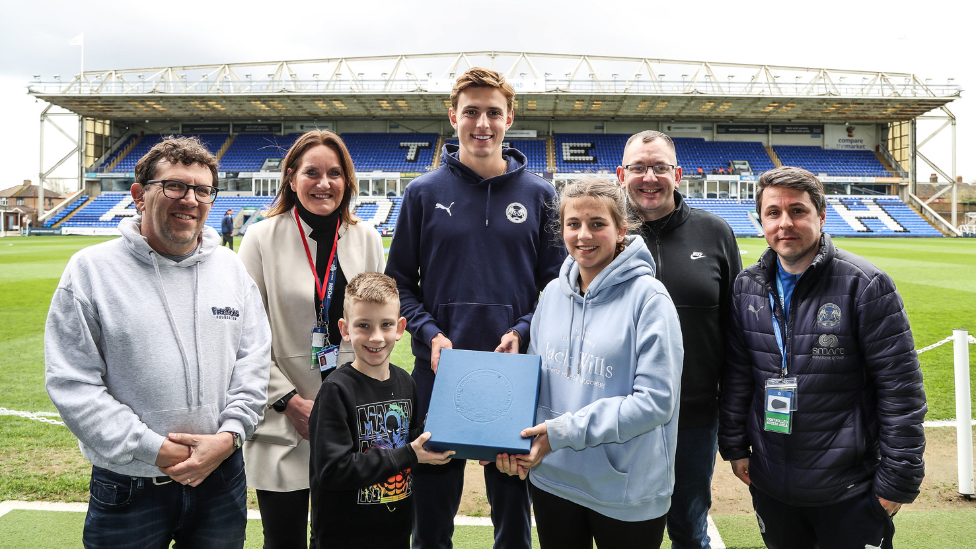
[309,273,454,549]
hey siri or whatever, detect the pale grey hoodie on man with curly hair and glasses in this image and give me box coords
[44,218,271,477]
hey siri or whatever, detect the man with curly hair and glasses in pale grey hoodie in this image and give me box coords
[44,138,271,549]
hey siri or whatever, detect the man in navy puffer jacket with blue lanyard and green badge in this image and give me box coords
[719,167,927,549]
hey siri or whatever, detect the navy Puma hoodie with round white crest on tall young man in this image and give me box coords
[386,145,566,368]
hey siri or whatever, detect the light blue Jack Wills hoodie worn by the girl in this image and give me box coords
[528,237,684,522]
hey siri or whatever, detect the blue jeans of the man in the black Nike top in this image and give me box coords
[668,421,718,549]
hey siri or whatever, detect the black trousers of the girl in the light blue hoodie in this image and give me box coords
[529,483,667,549]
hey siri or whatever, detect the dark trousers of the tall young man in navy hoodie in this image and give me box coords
[413,360,532,549]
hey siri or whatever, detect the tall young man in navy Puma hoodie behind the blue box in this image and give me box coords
[386,68,565,548]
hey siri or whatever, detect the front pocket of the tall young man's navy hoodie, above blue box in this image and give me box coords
[437,303,515,352]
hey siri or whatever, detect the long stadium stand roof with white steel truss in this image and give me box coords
[28,52,961,123]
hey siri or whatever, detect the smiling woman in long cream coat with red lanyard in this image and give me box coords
[240,131,385,548]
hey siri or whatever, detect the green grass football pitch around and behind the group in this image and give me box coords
[0,233,976,549]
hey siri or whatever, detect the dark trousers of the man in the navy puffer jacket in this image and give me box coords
[749,486,895,549]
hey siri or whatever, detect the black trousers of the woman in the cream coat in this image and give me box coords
[255,490,315,549]
